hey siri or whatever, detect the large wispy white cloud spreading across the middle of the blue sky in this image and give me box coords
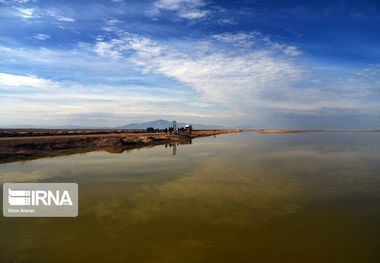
[96,33,303,104]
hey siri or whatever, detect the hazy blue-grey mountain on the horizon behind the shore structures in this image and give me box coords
[115,120,226,129]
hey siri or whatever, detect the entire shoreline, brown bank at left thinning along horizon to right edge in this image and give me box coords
[0,129,380,163]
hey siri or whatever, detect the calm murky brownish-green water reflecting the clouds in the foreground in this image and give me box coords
[0,133,380,263]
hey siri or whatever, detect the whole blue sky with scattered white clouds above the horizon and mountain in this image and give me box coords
[0,0,380,129]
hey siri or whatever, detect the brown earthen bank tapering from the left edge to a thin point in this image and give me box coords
[0,130,240,163]
